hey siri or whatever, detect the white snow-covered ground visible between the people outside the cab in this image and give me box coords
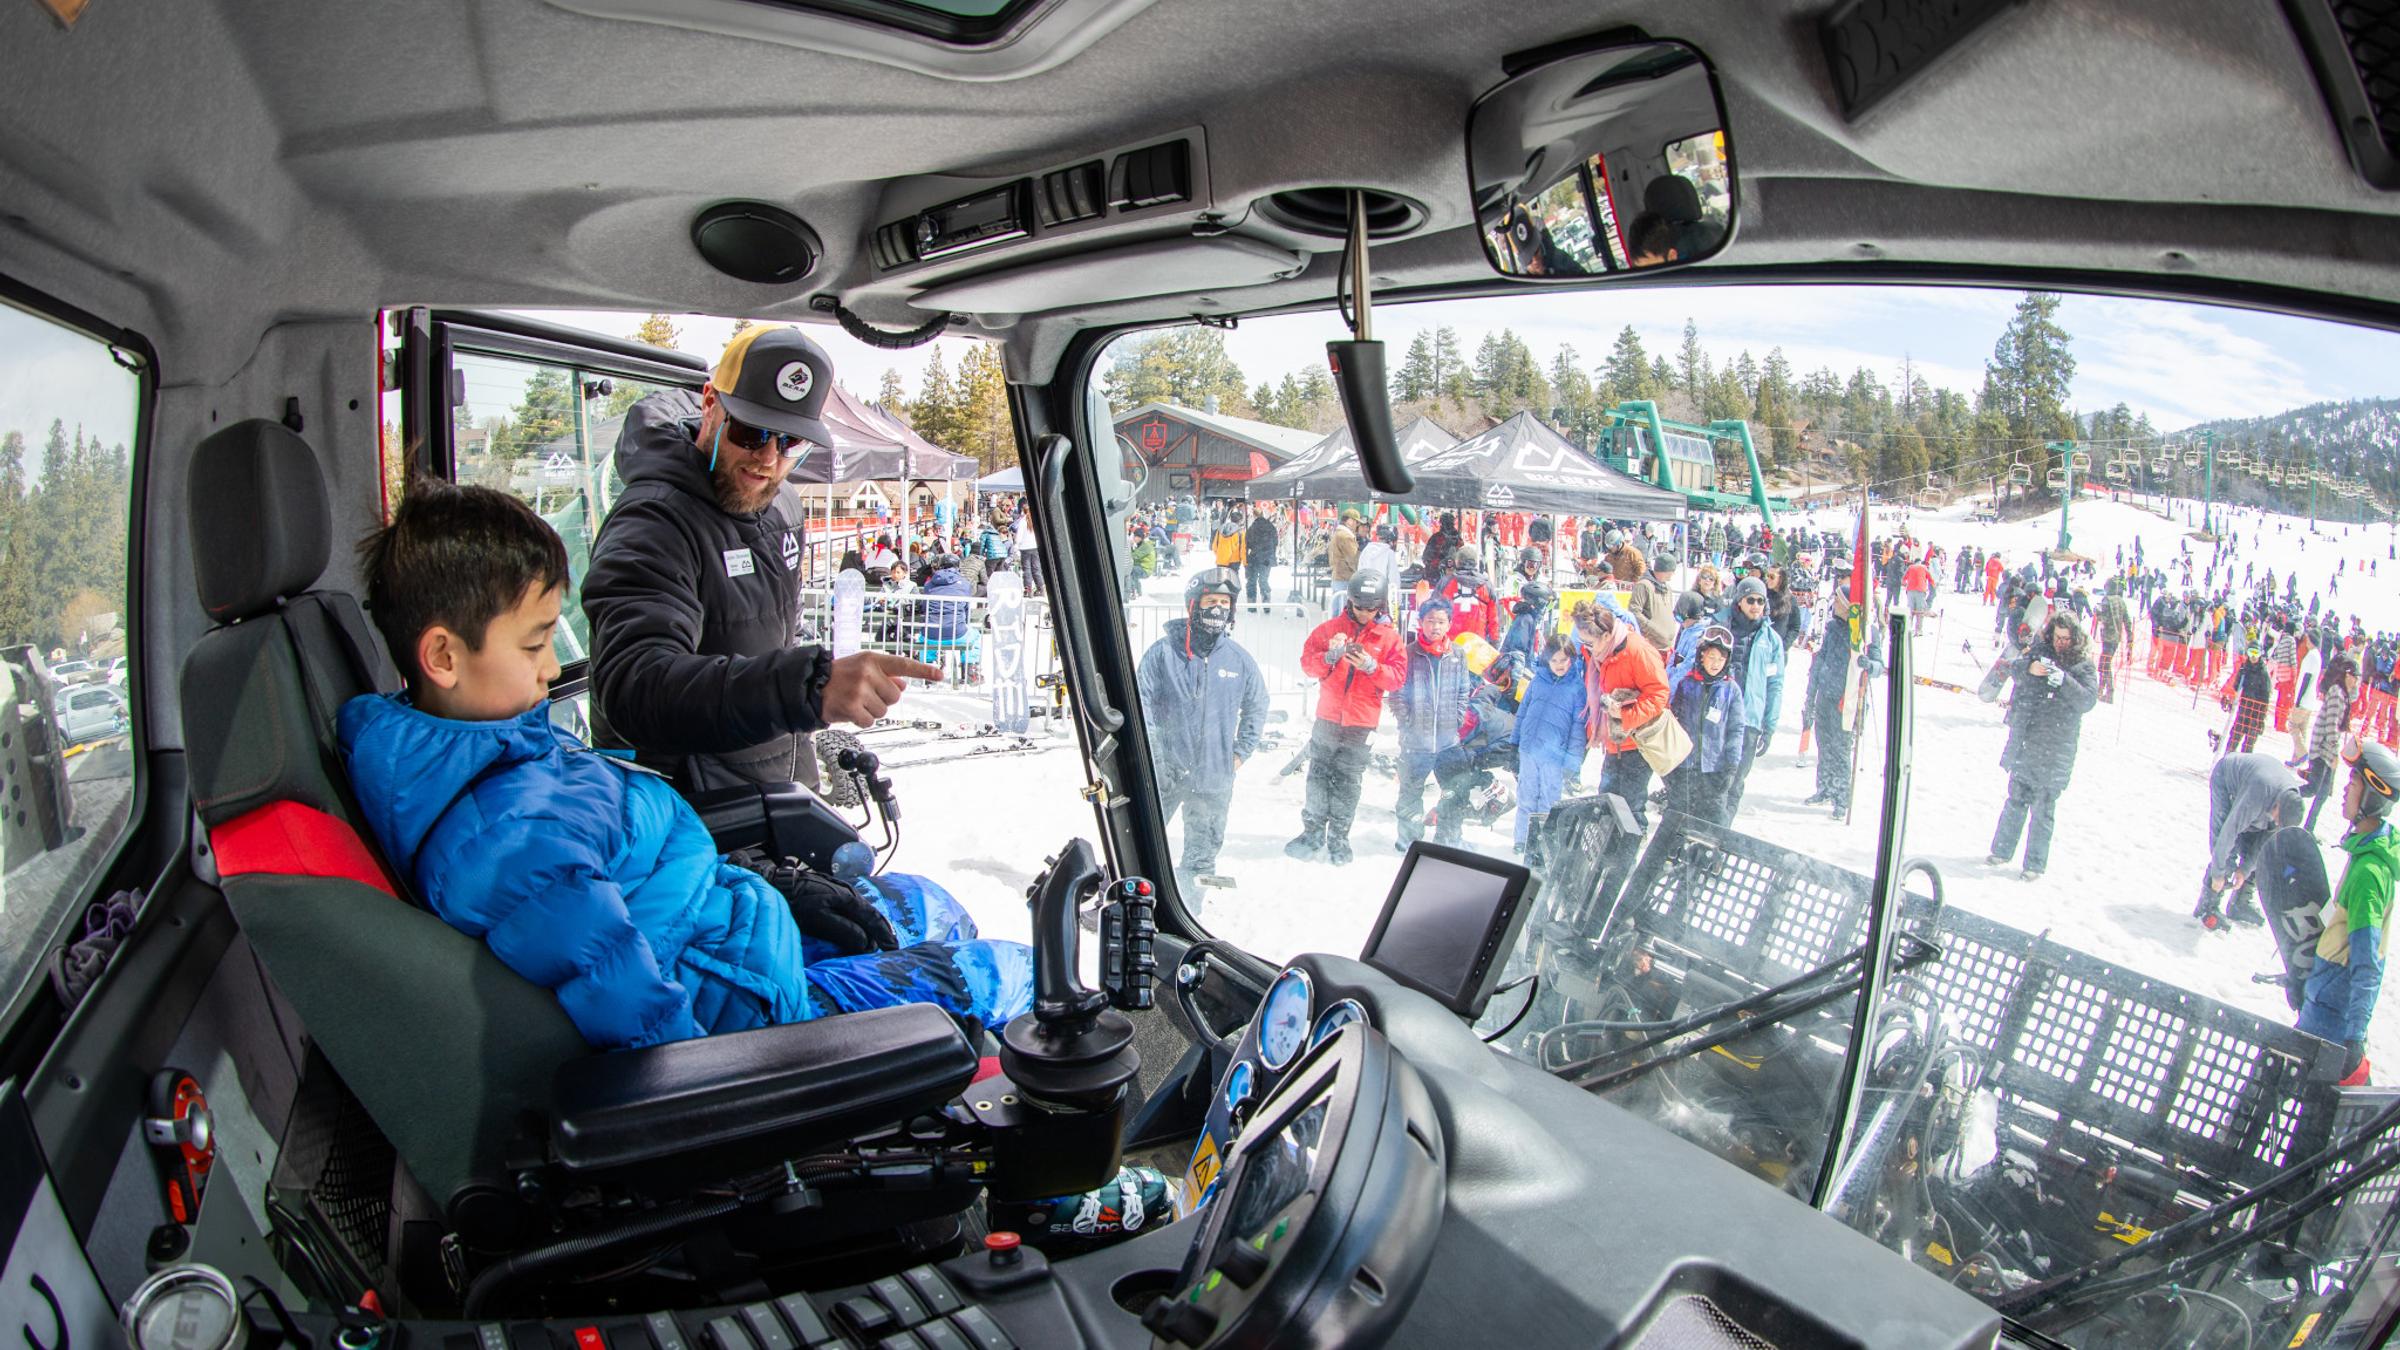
[869,487,2400,1076]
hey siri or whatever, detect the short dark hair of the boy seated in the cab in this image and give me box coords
[358,478,566,685]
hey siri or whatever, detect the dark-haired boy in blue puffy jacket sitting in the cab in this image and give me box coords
[338,483,1032,1050]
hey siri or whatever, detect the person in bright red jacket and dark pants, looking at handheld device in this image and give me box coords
[1284,572,1409,865]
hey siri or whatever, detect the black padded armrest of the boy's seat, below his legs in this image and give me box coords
[550,1004,979,1184]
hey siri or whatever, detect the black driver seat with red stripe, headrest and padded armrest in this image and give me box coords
[182,420,979,1252]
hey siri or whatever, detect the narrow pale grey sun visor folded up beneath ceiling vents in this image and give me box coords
[910,235,1308,315]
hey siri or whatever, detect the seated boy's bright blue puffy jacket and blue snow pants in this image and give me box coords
[338,694,1032,1047]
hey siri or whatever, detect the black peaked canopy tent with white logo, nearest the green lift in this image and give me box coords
[1406,413,1685,521]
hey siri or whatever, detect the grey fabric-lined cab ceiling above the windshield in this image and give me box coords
[0,0,2400,384]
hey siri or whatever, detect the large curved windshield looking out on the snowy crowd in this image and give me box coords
[1092,285,2400,1345]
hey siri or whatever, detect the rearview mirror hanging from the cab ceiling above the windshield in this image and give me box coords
[1466,41,1735,281]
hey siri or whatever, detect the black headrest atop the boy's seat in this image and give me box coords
[185,418,334,625]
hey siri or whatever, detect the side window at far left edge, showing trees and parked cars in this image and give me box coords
[0,305,142,997]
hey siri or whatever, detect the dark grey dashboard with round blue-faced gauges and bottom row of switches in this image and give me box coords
[121,954,2002,1350]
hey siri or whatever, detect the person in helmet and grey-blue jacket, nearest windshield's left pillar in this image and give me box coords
[1135,567,1267,893]
